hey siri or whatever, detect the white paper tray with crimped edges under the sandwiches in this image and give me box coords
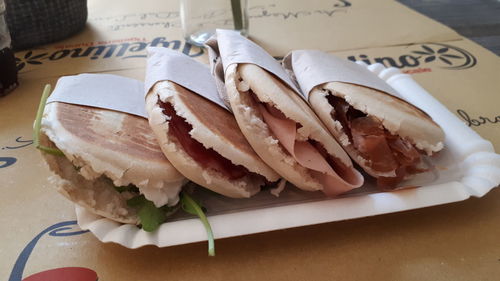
[76,63,500,248]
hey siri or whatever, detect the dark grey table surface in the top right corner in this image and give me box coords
[398,0,500,55]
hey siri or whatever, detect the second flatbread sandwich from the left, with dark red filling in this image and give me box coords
[146,48,279,198]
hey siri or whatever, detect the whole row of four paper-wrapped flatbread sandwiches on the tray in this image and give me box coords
[35,33,444,234]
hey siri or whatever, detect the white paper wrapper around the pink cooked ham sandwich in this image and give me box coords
[206,29,302,101]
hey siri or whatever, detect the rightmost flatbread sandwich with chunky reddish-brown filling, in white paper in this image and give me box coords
[284,50,444,189]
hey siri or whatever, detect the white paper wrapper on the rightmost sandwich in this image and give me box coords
[283,50,400,99]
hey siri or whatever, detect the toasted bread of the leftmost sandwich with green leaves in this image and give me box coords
[41,102,186,218]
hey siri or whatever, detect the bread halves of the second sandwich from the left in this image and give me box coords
[146,81,279,198]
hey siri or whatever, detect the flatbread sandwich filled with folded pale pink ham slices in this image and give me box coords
[209,30,363,196]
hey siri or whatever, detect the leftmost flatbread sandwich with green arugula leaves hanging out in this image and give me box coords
[35,74,186,231]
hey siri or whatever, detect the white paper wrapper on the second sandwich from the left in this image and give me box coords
[144,47,227,110]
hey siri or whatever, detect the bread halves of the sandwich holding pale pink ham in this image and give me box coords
[225,64,363,191]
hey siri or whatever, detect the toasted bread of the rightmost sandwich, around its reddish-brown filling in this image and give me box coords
[309,82,444,177]
